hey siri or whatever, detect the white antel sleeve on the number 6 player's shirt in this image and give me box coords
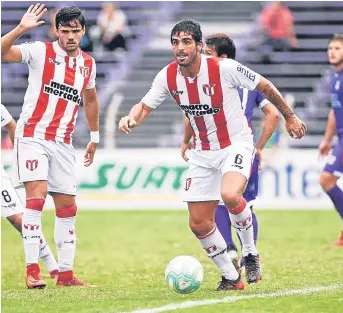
[220,59,261,90]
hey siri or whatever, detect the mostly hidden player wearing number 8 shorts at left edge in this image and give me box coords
[1,104,58,278]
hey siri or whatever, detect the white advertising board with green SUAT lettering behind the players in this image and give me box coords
[2,149,342,209]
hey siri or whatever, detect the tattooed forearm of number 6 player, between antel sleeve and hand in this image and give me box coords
[256,77,295,121]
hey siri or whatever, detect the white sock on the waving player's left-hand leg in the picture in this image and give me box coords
[22,208,42,265]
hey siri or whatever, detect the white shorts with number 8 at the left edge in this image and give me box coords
[1,168,24,217]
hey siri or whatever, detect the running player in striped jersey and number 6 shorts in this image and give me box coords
[119,20,306,290]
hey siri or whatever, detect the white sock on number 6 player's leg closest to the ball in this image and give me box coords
[198,226,239,280]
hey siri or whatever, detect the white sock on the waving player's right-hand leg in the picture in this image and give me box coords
[55,216,76,272]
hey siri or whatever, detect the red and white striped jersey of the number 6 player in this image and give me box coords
[141,55,261,150]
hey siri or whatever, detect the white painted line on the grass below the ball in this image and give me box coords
[126,284,343,313]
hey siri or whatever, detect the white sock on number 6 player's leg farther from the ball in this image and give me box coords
[229,200,258,256]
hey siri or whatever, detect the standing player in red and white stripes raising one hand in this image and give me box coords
[1,4,99,288]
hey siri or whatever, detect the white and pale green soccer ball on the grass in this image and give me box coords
[165,255,204,294]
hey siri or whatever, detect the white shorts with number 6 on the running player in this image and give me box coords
[183,143,255,202]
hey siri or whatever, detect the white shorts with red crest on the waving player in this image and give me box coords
[14,138,76,195]
